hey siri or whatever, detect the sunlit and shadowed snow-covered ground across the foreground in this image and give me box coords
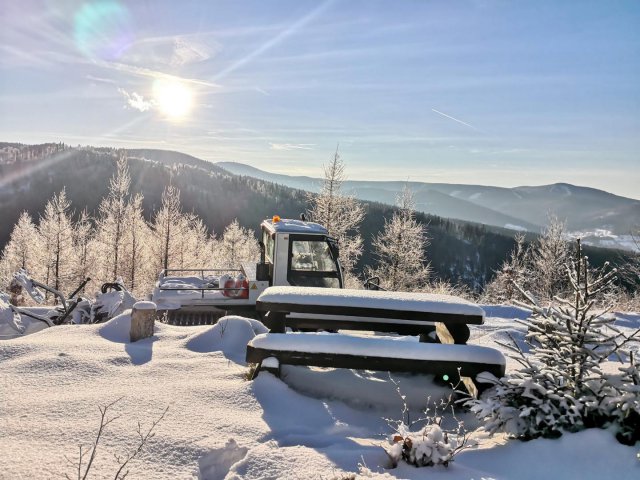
[0,307,640,480]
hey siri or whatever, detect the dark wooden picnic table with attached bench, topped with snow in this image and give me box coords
[246,287,505,389]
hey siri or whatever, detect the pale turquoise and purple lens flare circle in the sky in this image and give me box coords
[74,0,134,60]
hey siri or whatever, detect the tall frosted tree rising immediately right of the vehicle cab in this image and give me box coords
[308,150,364,287]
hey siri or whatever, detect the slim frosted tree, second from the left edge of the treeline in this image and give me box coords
[33,190,75,293]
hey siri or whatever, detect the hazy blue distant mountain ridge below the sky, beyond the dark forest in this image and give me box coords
[217,162,640,248]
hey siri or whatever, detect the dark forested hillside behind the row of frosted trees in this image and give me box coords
[0,146,628,290]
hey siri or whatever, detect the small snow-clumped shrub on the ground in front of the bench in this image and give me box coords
[385,379,470,467]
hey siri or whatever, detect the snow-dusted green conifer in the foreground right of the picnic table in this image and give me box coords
[468,241,640,443]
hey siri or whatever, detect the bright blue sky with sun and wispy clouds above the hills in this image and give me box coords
[0,0,640,198]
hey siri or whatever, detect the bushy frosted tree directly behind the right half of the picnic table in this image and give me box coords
[368,187,430,291]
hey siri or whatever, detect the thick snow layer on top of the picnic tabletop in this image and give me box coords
[258,287,484,317]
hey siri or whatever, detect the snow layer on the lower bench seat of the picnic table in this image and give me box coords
[249,333,505,365]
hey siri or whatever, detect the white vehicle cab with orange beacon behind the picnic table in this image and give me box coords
[260,215,344,288]
